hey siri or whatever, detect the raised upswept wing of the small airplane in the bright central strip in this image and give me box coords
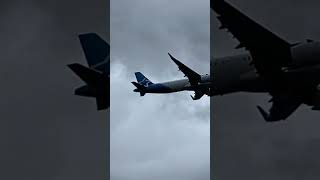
[168,53,201,86]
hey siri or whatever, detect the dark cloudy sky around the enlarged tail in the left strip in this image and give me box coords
[0,0,109,180]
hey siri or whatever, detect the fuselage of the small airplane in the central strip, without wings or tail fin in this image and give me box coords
[144,75,210,93]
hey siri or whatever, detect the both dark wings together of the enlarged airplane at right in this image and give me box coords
[210,0,303,121]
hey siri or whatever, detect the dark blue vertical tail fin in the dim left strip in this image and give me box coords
[79,33,110,74]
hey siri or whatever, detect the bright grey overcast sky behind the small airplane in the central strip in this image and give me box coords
[110,0,210,180]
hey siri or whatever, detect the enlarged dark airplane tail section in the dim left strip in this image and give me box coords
[68,33,110,110]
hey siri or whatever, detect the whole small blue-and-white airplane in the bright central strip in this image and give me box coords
[131,53,210,100]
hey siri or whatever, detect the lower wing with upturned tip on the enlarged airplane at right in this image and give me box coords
[257,96,303,122]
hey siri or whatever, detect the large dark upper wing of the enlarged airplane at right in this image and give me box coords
[210,0,291,94]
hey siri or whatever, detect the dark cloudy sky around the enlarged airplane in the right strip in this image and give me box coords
[211,0,320,180]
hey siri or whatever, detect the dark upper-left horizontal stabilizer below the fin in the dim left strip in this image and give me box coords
[68,63,104,85]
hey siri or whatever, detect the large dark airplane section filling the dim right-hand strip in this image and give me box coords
[210,0,320,122]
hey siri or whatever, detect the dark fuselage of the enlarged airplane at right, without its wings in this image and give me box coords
[210,41,320,104]
